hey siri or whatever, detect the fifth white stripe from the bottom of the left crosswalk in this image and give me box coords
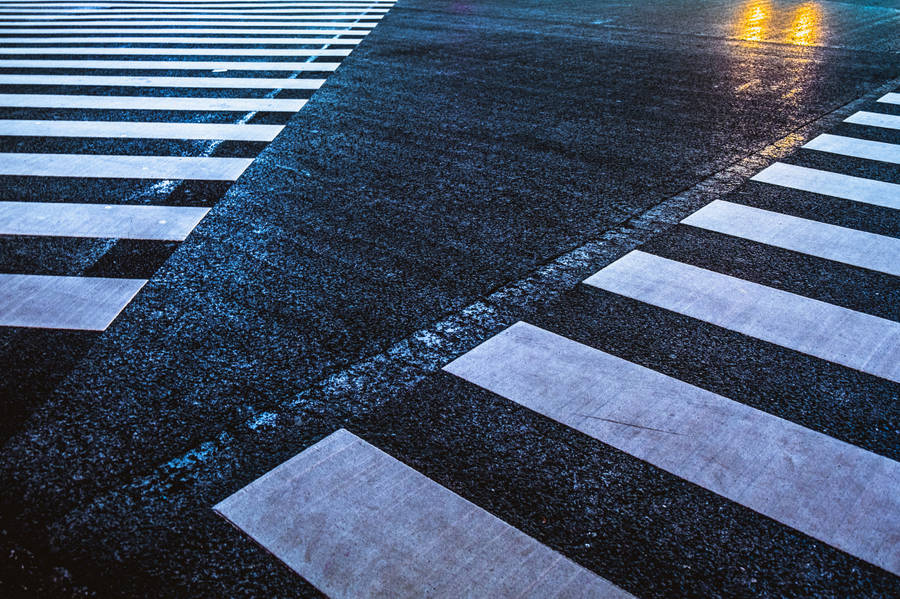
[0,94,306,112]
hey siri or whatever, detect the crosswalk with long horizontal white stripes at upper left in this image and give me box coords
[0,0,394,331]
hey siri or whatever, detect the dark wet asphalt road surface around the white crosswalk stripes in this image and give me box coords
[0,0,900,598]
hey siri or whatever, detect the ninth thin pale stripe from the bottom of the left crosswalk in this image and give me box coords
[0,36,363,46]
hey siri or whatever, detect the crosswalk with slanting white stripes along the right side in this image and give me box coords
[215,94,900,597]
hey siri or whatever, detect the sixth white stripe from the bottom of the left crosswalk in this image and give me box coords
[0,75,325,89]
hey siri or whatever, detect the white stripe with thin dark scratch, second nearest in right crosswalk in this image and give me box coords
[445,323,900,574]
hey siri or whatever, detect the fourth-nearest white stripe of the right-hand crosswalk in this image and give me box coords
[681,200,900,276]
